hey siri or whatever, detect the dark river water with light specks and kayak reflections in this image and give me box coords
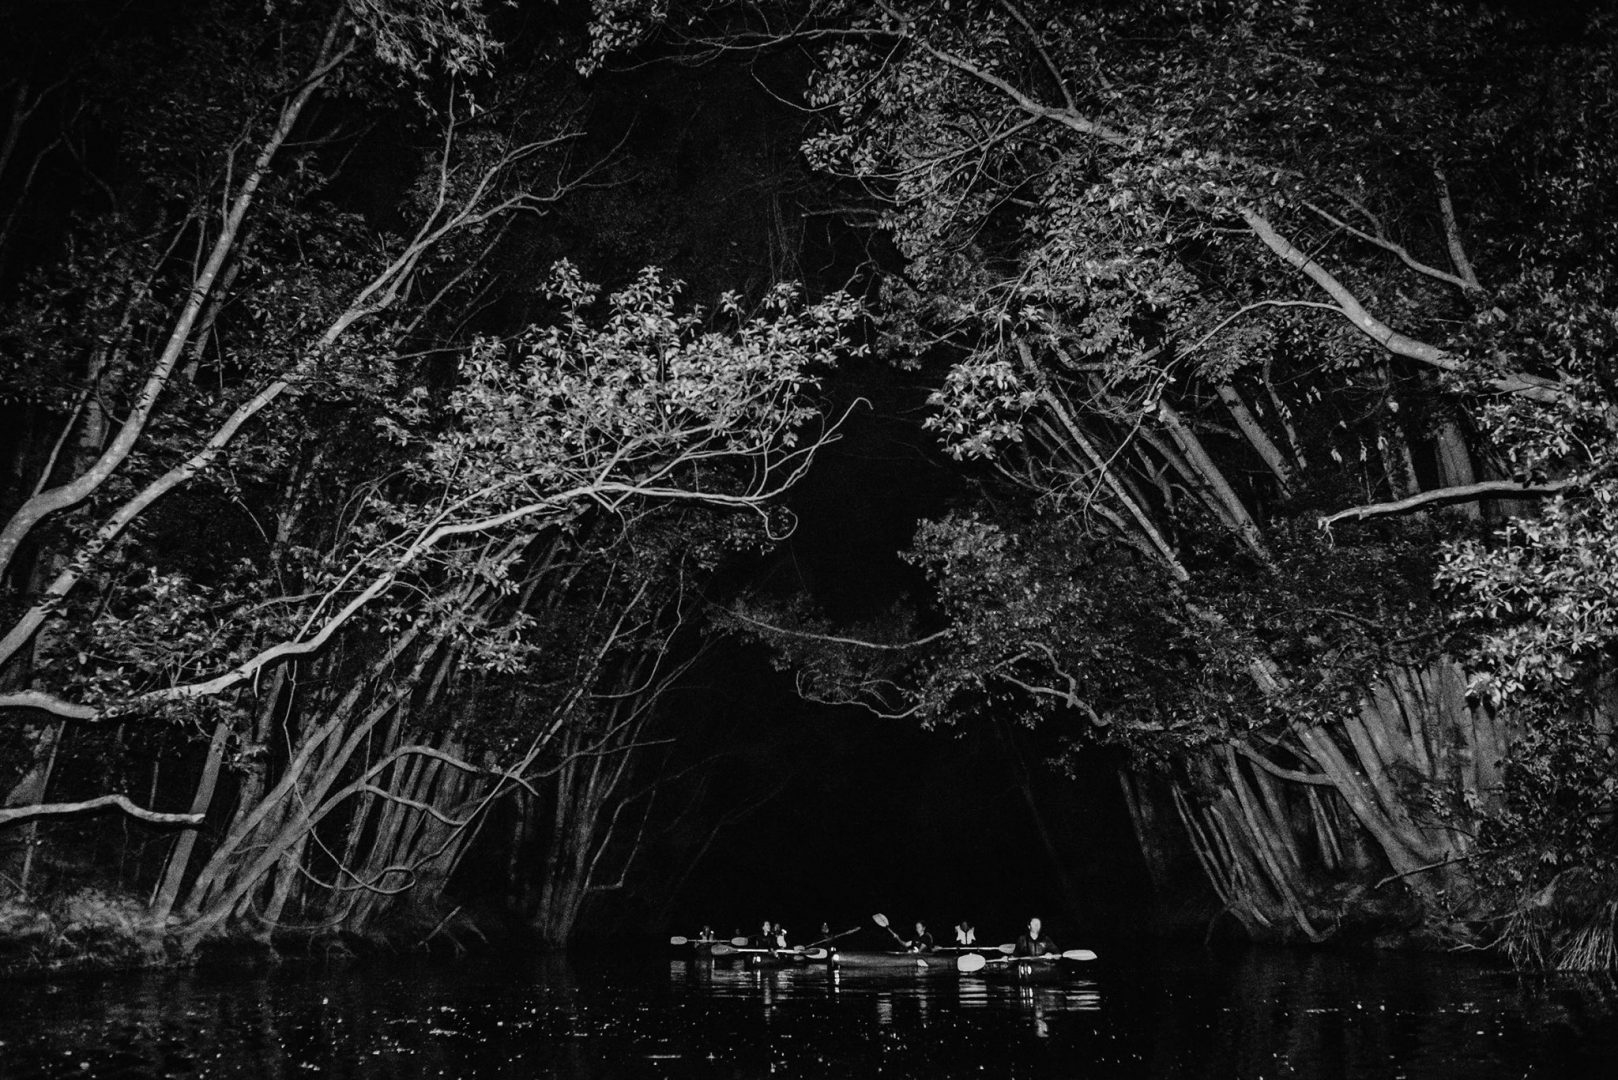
[0,947,1618,1080]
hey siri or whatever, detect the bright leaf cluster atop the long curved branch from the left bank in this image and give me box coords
[422,264,859,507]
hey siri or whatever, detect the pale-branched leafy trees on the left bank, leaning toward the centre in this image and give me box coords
[0,0,856,947]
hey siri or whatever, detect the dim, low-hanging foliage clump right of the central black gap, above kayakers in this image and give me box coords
[909,515,1223,751]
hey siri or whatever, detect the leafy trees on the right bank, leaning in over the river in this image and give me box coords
[705,0,1613,955]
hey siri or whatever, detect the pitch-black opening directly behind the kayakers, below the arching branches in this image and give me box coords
[670,683,1144,944]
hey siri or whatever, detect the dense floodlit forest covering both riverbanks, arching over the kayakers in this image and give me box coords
[0,0,1618,968]
